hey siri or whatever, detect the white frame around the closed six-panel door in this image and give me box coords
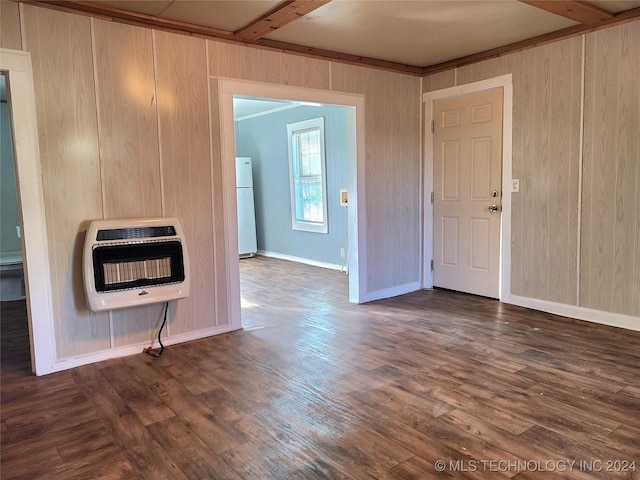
[422,74,513,302]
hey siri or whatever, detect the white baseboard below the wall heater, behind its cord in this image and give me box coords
[46,325,239,373]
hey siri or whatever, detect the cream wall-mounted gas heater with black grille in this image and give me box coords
[83,218,190,312]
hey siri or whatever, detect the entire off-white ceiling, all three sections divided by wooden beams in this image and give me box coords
[67,0,640,68]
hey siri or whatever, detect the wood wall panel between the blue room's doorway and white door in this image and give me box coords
[332,64,421,292]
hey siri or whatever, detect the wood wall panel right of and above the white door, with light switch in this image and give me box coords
[457,38,582,305]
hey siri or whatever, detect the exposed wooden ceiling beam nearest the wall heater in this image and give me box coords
[233,0,331,42]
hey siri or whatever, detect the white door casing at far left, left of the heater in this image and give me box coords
[0,49,56,375]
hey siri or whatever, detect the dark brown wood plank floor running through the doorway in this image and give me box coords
[0,257,640,480]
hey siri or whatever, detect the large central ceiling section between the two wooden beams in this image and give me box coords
[265,0,576,66]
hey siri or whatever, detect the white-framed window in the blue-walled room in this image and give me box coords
[287,117,328,233]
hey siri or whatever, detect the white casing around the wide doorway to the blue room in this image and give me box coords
[218,79,367,327]
